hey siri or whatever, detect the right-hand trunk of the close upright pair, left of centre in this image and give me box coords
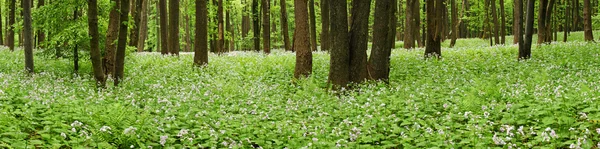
[169,0,179,55]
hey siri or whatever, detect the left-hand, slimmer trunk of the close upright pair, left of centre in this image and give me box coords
[158,0,169,55]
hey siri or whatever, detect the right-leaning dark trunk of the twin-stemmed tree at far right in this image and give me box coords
[519,0,535,60]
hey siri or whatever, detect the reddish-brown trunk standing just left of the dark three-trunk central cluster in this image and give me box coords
[294,0,312,79]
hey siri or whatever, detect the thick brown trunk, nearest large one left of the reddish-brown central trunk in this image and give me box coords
[194,0,208,66]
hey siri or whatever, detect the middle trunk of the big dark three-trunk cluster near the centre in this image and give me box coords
[346,0,370,82]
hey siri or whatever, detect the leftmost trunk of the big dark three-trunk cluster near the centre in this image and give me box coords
[328,0,356,88]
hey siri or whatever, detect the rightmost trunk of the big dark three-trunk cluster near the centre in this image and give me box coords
[369,0,396,81]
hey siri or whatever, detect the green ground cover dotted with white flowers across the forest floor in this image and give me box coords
[0,33,600,148]
